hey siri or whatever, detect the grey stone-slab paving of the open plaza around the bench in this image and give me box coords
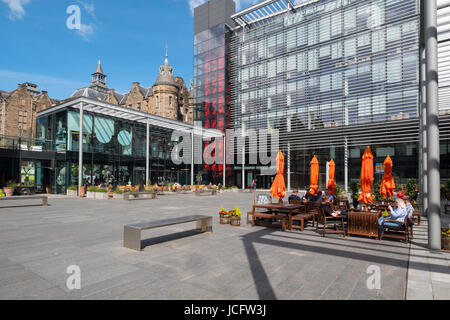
[0,192,450,300]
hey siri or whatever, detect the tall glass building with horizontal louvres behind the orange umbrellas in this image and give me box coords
[194,0,450,188]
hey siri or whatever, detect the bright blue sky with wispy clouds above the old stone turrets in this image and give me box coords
[0,0,254,99]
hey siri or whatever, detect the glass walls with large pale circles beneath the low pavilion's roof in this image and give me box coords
[37,108,190,193]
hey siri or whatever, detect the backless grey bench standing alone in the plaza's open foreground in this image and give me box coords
[123,215,212,251]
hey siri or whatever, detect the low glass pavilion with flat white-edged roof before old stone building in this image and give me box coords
[32,97,221,193]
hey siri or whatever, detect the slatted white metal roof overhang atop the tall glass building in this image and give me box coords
[231,0,318,27]
